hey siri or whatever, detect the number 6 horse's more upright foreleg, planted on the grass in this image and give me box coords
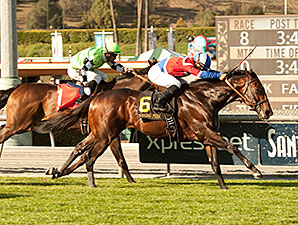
[205,145,228,189]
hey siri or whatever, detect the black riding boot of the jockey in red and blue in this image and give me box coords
[153,85,179,112]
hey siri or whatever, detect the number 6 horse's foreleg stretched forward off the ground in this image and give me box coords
[204,130,262,178]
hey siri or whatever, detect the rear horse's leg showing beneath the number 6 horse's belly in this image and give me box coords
[110,137,136,183]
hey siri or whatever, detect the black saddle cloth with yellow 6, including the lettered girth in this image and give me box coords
[138,91,179,140]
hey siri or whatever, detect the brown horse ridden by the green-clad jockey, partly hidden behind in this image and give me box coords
[0,60,157,182]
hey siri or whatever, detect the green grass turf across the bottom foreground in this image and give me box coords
[0,177,298,225]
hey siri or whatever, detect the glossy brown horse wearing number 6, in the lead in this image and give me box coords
[33,70,273,189]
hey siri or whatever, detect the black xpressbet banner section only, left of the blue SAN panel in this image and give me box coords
[138,124,258,165]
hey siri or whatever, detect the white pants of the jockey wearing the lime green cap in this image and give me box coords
[67,67,107,84]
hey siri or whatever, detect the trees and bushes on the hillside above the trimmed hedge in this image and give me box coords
[26,0,266,29]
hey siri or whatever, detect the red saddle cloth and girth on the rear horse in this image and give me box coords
[55,82,90,134]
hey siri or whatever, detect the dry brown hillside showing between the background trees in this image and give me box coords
[17,0,298,29]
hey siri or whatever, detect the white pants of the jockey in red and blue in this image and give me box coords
[148,64,186,88]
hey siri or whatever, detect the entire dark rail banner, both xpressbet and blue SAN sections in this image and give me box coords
[138,123,298,165]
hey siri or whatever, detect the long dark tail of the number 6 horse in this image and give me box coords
[31,95,96,134]
